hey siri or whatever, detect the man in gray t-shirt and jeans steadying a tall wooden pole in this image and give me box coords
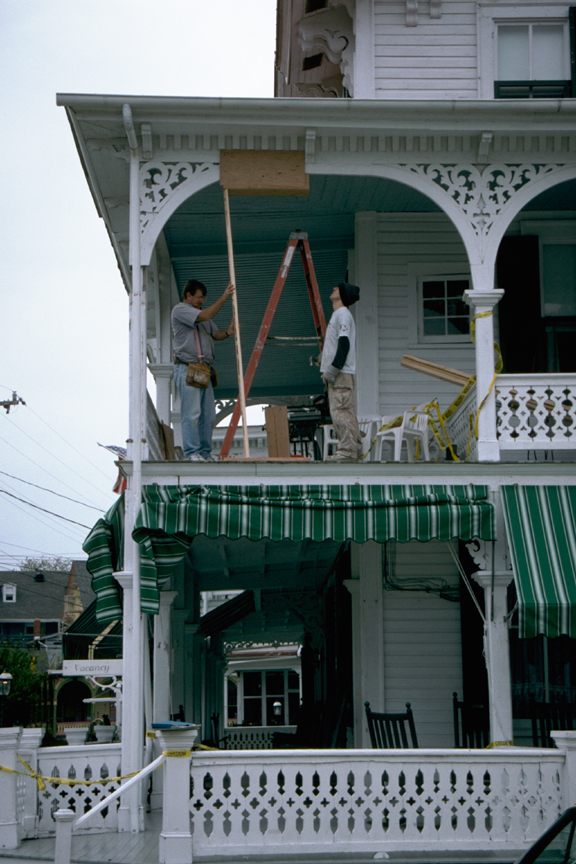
[171,279,235,462]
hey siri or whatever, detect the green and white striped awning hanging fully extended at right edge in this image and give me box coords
[503,486,576,637]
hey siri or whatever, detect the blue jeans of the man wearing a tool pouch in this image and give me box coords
[174,363,216,458]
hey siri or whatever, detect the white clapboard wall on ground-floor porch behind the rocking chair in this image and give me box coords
[383,541,462,747]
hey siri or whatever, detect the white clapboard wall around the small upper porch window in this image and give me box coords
[377,213,475,415]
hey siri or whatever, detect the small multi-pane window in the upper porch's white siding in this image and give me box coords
[418,274,470,342]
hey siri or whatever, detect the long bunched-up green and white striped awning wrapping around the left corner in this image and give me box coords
[84,485,495,621]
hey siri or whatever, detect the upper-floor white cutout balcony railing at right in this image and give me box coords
[496,374,576,450]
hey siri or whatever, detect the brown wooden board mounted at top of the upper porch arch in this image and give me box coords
[220,150,310,196]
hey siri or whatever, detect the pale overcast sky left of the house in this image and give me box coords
[0,0,276,581]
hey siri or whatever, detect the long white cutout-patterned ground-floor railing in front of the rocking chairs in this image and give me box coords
[190,748,565,856]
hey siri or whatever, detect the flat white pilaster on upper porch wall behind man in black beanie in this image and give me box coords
[352,213,380,418]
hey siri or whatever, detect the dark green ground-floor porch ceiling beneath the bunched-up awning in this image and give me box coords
[188,534,341,591]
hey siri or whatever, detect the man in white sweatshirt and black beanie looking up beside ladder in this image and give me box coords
[320,282,363,462]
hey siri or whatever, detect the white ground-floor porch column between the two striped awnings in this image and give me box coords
[473,570,513,743]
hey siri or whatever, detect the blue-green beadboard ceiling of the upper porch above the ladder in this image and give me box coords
[164,175,439,398]
